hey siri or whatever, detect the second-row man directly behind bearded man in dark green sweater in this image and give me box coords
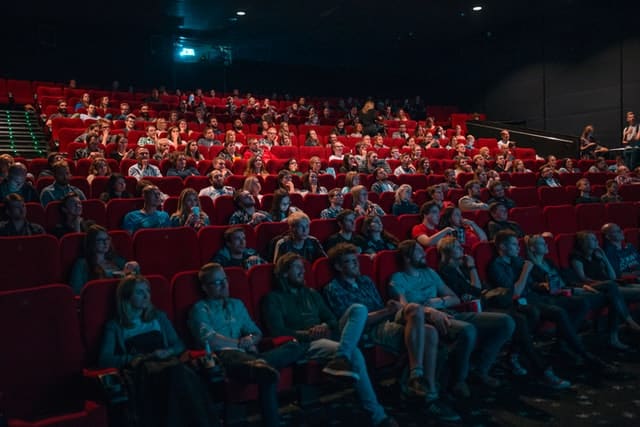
[273,211,327,264]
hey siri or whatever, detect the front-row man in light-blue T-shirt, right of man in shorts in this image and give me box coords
[389,240,515,397]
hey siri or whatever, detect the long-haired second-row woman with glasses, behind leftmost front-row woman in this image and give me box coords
[69,224,140,295]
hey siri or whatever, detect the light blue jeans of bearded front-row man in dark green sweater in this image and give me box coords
[307,304,386,424]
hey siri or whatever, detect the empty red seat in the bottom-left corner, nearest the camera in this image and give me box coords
[0,284,107,427]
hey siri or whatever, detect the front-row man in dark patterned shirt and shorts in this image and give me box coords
[324,243,460,421]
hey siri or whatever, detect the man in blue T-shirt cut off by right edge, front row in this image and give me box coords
[600,222,640,280]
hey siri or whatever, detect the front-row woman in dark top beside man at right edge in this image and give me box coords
[569,231,640,350]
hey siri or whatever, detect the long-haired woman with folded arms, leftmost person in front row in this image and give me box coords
[98,275,219,427]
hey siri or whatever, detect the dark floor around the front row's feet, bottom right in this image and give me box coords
[250,334,640,427]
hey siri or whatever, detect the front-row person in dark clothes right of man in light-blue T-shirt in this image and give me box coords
[438,236,571,390]
